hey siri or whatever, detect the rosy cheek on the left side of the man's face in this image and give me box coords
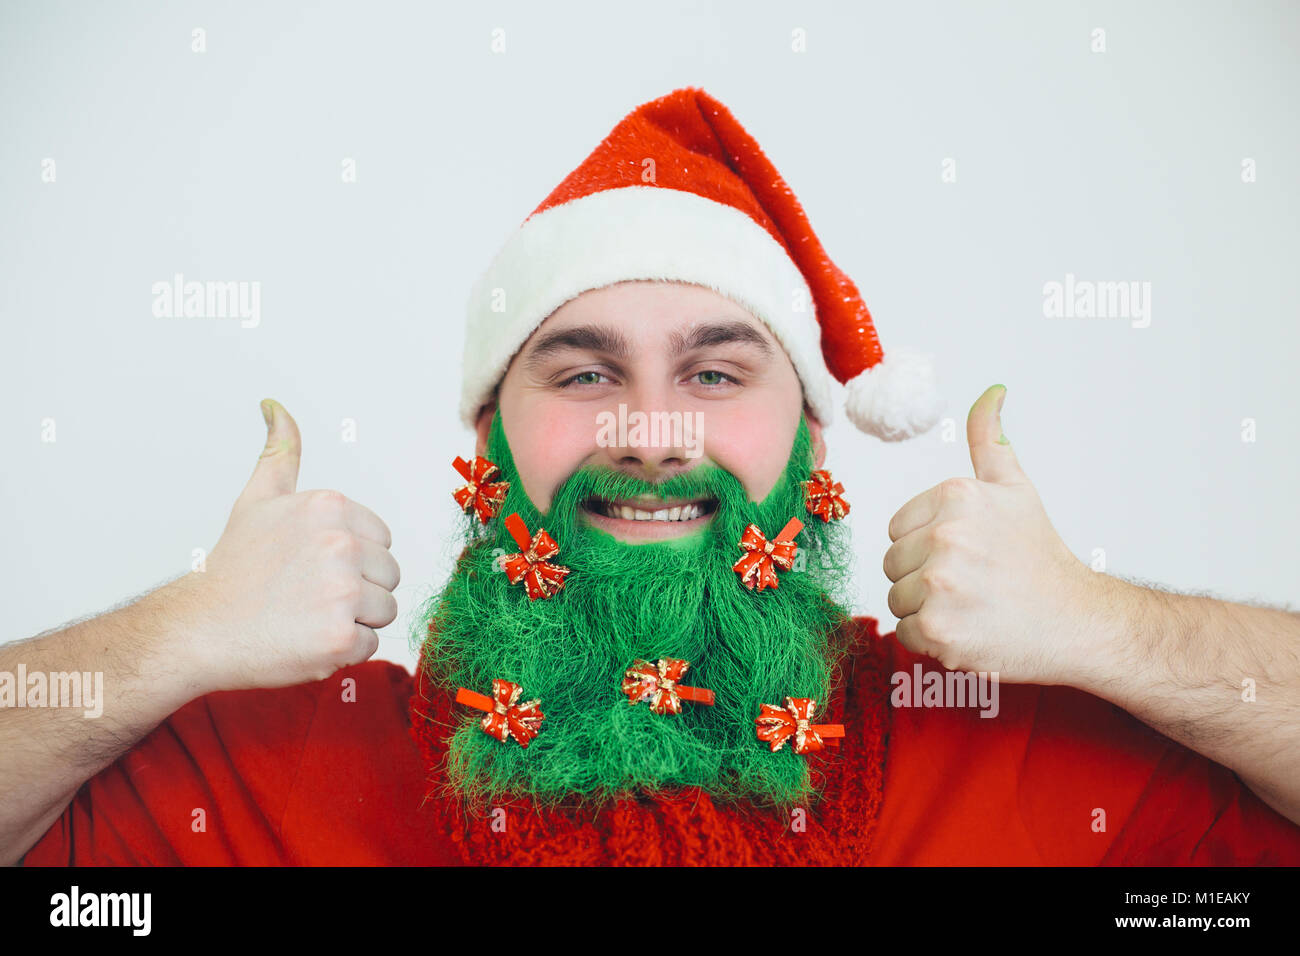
[502,402,595,514]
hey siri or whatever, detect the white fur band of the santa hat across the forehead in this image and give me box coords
[460,186,833,428]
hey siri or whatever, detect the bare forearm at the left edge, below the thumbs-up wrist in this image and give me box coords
[0,579,204,864]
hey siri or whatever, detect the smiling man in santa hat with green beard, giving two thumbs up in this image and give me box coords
[10,90,1300,864]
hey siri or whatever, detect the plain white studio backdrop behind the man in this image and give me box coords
[0,0,1300,665]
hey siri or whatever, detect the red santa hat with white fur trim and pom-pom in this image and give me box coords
[460,87,941,441]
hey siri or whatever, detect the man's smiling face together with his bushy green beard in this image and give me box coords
[415,282,852,803]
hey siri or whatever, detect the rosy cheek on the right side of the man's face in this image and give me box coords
[705,402,801,502]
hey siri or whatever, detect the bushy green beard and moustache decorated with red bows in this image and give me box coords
[412,411,852,806]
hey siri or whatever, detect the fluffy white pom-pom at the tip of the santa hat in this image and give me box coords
[844,349,944,441]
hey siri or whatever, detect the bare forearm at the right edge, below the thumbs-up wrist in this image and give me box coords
[1083,579,1300,823]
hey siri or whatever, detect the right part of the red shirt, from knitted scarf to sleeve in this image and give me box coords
[878,633,1300,865]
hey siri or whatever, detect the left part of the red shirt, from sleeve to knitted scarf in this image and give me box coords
[23,661,459,866]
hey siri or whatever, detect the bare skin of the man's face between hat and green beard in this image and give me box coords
[477,282,826,542]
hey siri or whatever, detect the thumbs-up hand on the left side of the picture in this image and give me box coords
[172,399,400,692]
